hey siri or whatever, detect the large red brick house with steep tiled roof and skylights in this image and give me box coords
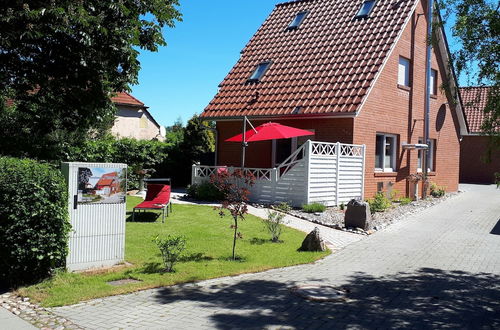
[197,0,467,201]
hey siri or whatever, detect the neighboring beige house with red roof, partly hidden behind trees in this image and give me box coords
[111,92,165,141]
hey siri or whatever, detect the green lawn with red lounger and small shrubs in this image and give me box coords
[18,197,330,307]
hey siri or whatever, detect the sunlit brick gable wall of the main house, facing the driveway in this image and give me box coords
[354,0,460,198]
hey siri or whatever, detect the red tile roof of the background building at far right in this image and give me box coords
[460,87,491,133]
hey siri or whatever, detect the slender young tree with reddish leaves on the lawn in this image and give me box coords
[210,169,255,260]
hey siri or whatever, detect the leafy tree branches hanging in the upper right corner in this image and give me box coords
[439,0,500,158]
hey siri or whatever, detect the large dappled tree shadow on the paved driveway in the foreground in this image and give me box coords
[155,268,500,329]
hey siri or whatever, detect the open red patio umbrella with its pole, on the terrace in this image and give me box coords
[226,116,314,168]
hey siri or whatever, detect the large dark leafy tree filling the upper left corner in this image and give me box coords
[0,0,180,159]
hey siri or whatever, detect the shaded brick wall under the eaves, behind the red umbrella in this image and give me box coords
[217,118,353,168]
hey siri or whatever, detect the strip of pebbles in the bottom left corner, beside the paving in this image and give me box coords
[0,293,83,330]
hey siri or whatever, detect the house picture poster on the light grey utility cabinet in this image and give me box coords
[78,167,127,204]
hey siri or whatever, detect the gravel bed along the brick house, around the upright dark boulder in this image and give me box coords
[289,193,458,235]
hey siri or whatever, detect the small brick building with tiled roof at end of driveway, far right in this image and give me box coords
[460,87,500,183]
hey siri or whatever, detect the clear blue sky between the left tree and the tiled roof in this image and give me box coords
[131,0,464,126]
